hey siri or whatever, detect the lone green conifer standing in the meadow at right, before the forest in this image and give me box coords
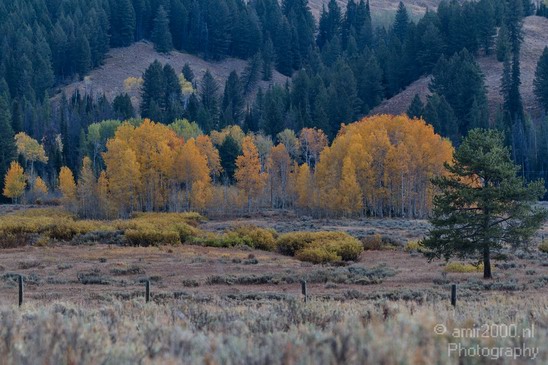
[421,129,548,279]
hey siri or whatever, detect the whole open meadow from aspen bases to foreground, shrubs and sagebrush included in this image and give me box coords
[0,208,548,364]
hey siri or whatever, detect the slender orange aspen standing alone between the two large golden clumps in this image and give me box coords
[234,137,266,212]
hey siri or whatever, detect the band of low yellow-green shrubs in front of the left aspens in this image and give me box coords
[0,208,363,264]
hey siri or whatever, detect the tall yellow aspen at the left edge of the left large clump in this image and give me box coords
[103,138,141,218]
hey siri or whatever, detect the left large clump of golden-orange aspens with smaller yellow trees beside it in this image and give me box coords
[60,119,220,218]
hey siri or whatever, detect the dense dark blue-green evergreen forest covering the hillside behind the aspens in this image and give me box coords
[0,0,548,209]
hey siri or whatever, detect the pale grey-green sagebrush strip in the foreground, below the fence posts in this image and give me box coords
[0,296,548,365]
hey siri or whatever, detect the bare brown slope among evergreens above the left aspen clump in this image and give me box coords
[56,42,287,107]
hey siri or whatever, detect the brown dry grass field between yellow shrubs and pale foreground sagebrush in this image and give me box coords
[0,210,548,306]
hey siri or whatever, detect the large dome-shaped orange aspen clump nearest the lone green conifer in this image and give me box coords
[306,115,453,217]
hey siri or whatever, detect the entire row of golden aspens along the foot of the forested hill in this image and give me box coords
[3,115,453,219]
